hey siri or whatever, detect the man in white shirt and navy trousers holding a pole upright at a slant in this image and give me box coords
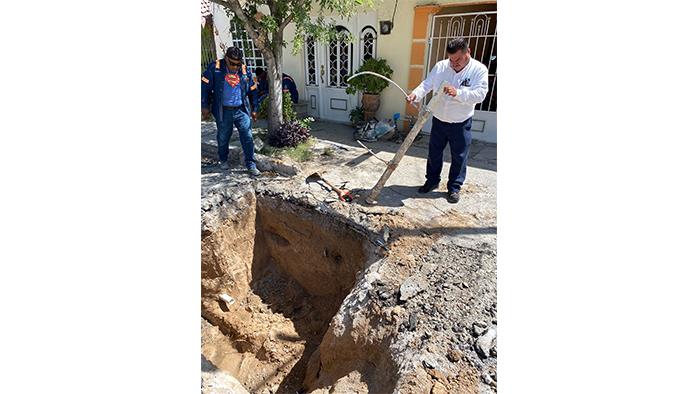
[406,38,488,204]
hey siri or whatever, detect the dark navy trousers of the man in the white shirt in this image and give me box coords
[425,116,472,192]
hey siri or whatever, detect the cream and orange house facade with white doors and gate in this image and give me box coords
[212,0,497,142]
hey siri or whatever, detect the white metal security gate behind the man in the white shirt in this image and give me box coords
[424,11,498,142]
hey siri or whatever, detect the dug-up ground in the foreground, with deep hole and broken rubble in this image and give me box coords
[201,132,498,394]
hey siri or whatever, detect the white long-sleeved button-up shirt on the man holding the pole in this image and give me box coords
[413,58,488,123]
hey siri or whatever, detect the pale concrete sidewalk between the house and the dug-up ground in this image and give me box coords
[201,121,497,248]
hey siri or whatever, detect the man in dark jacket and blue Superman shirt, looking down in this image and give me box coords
[201,47,260,176]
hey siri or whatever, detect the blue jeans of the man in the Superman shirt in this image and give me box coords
[216,108,256,169]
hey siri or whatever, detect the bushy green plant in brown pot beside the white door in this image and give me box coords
[346,58,394,121]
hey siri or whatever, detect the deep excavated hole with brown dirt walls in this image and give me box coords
[202,193,373,393]
